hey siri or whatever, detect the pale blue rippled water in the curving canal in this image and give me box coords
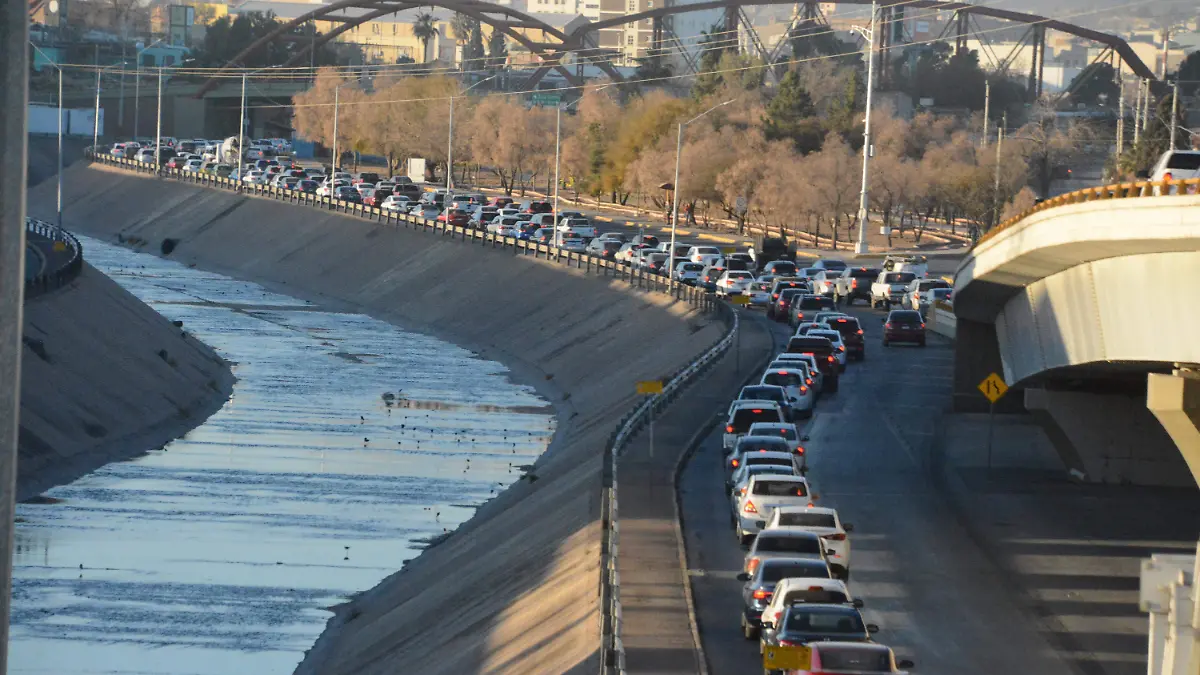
[10,240,554,675]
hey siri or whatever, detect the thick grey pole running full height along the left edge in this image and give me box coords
[0,2,29,673]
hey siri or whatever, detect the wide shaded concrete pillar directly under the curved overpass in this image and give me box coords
[1025,388,1196,488]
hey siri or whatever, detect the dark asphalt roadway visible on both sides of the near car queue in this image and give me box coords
[680,309,1070,675]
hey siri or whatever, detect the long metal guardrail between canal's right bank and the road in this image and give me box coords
[89,154,740,675]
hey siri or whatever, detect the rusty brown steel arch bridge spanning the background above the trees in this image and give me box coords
[197,0,1154,96]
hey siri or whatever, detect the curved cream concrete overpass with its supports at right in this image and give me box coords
[954,179,1200,488]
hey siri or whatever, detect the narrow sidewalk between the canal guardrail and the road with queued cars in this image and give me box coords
[617,312,773,674]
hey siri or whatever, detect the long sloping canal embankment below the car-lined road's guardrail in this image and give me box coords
[30,166,724,675]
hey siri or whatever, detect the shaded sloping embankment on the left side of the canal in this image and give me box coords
[17,263,233,498]
